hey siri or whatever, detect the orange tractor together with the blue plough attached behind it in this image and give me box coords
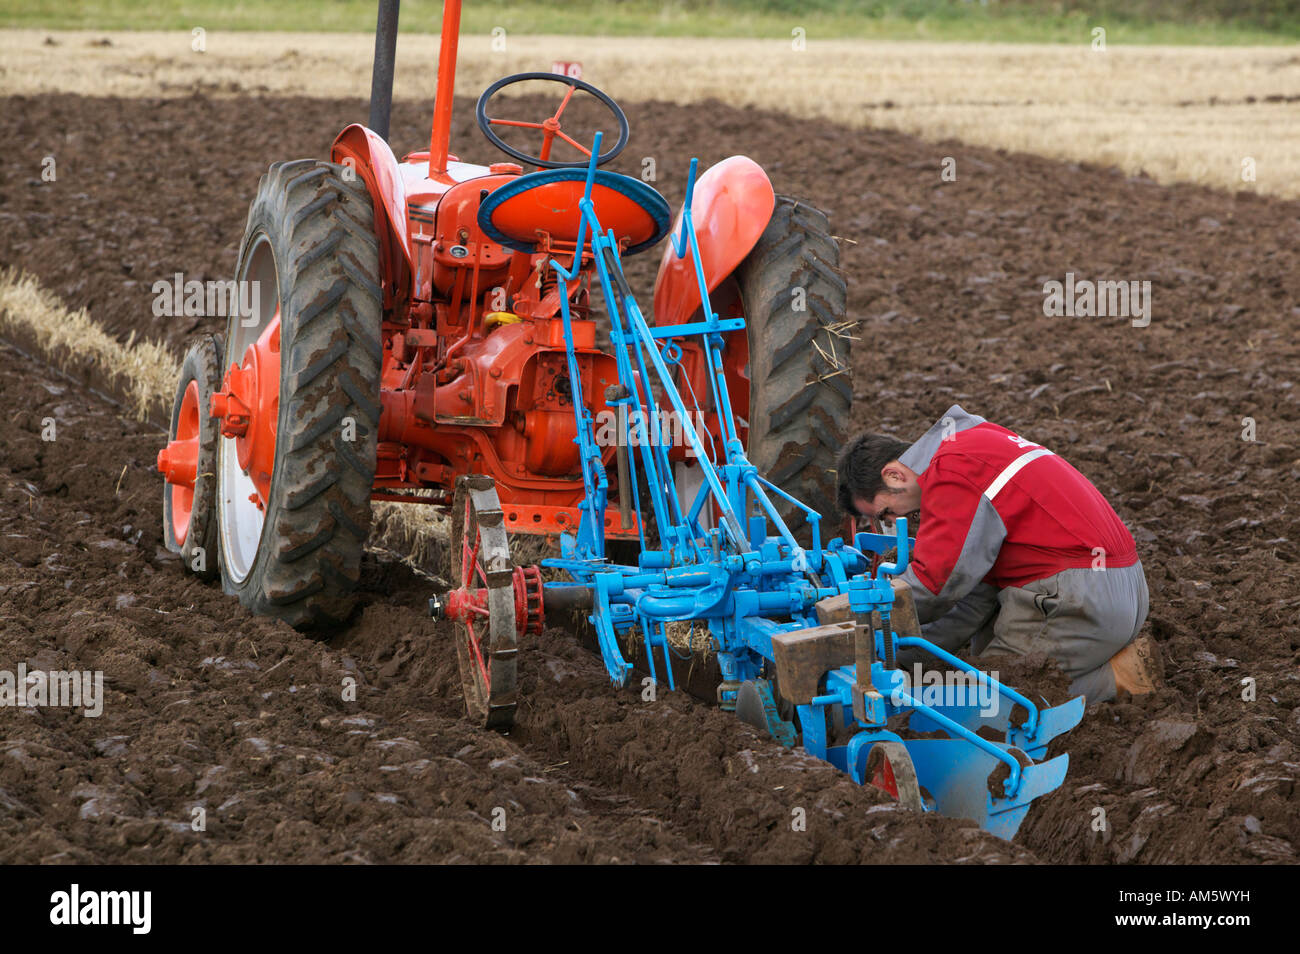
[159,0,1083,838]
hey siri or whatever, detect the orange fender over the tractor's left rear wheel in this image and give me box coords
[330,122,415,307]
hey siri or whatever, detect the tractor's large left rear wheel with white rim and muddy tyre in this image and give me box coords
[217,160,382,630]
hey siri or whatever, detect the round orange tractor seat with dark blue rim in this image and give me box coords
[478,169,672,255]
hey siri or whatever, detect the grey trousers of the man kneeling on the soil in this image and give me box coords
[907,561,1151,704]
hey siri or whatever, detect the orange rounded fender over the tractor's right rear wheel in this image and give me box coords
[654,156,776,325]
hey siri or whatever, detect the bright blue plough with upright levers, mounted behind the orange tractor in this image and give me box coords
[491,135,1084,838]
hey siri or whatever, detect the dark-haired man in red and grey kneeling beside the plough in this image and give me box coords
[839,404,1158,704]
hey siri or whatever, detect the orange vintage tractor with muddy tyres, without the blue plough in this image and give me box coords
[159,0,852,629]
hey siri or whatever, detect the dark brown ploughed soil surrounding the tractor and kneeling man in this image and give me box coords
[0,96,1300,863]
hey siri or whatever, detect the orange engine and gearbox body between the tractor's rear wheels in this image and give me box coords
[376,160,634,534]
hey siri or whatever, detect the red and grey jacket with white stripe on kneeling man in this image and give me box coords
[898,404,1138,623]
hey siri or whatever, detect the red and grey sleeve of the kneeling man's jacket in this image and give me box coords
[902,459,1006,623]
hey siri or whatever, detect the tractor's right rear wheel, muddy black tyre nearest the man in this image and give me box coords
[719,195,853,538]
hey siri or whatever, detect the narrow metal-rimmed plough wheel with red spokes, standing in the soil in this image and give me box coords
[451,474,519,730]
